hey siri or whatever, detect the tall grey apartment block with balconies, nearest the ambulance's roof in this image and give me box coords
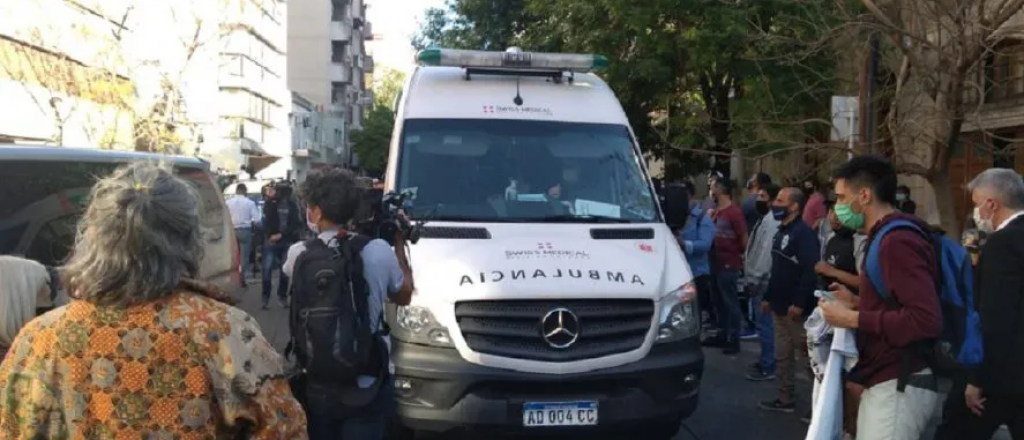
[288,0,374,165]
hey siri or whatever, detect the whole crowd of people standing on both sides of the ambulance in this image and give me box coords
[0,156,1024,440]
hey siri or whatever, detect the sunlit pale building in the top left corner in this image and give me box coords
[0,0,133,148]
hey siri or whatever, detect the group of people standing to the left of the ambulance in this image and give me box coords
[0,163,413,440]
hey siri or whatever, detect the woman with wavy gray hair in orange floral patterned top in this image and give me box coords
[0,163,306,440]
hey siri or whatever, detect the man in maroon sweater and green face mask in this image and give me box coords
[819,156,942,440]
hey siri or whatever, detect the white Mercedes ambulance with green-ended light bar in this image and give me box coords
[385,48,703,440]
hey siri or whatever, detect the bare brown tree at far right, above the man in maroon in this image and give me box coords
[827,0,1024,232]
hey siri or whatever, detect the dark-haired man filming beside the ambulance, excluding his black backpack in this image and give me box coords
[283,168,413,440]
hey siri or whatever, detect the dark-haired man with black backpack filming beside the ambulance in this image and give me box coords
[283,168,413,440]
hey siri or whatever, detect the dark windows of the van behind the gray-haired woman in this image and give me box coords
[0,161,224,266]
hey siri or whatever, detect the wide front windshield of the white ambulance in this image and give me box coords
[396,120,658,222]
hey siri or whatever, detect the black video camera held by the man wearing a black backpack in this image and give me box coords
[354,188,423,246]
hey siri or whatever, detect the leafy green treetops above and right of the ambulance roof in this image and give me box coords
[416,0,839,180]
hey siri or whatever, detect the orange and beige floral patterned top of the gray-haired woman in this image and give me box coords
[0,290,307,440]
